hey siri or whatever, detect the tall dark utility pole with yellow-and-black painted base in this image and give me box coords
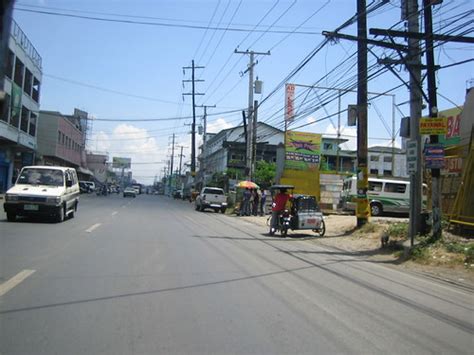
[356,0,370,227]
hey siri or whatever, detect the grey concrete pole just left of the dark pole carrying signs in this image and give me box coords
[407,0,423,246]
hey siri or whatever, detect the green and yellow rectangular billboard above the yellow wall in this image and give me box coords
[285,131,321,170]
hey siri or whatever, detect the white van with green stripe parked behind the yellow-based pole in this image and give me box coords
[341,176,426,216]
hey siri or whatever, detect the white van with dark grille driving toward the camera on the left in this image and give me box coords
[3,166,79,222]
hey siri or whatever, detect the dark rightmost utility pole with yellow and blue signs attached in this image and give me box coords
[423,0,441,239]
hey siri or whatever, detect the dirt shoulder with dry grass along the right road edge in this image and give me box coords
[235,215,474,287]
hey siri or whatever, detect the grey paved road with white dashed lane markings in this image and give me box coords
[0,195,474,354]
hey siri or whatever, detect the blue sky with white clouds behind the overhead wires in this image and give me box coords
[14,0,474,183]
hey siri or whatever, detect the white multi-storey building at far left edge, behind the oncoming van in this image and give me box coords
[0,20,42,193]
